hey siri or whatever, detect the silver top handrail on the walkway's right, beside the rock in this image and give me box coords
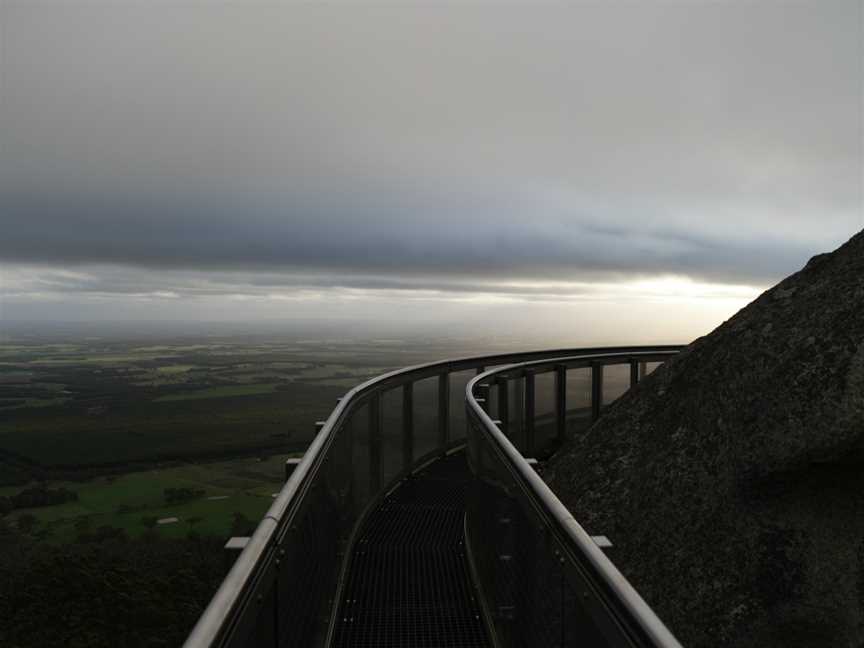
[465,347,681,648]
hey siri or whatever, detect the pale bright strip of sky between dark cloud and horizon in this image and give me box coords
[0,268,763,346]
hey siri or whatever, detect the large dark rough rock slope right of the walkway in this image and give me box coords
[544,232,864,648]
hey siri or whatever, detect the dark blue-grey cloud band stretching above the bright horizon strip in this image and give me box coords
[0,189,836,289]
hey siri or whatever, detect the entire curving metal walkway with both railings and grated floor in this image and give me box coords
[185,346,681,648]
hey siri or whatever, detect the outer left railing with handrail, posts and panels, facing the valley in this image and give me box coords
[185,347,677,648]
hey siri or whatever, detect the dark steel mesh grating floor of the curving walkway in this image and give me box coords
[334,453,490,648]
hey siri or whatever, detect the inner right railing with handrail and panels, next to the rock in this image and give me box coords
[465,350,679,648]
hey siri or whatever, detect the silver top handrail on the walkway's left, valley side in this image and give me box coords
[184,345,679,648]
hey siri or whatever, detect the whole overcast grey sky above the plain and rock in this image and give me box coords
[0,0,864,342]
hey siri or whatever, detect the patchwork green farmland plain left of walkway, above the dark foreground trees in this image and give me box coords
[0,338,460,543]
